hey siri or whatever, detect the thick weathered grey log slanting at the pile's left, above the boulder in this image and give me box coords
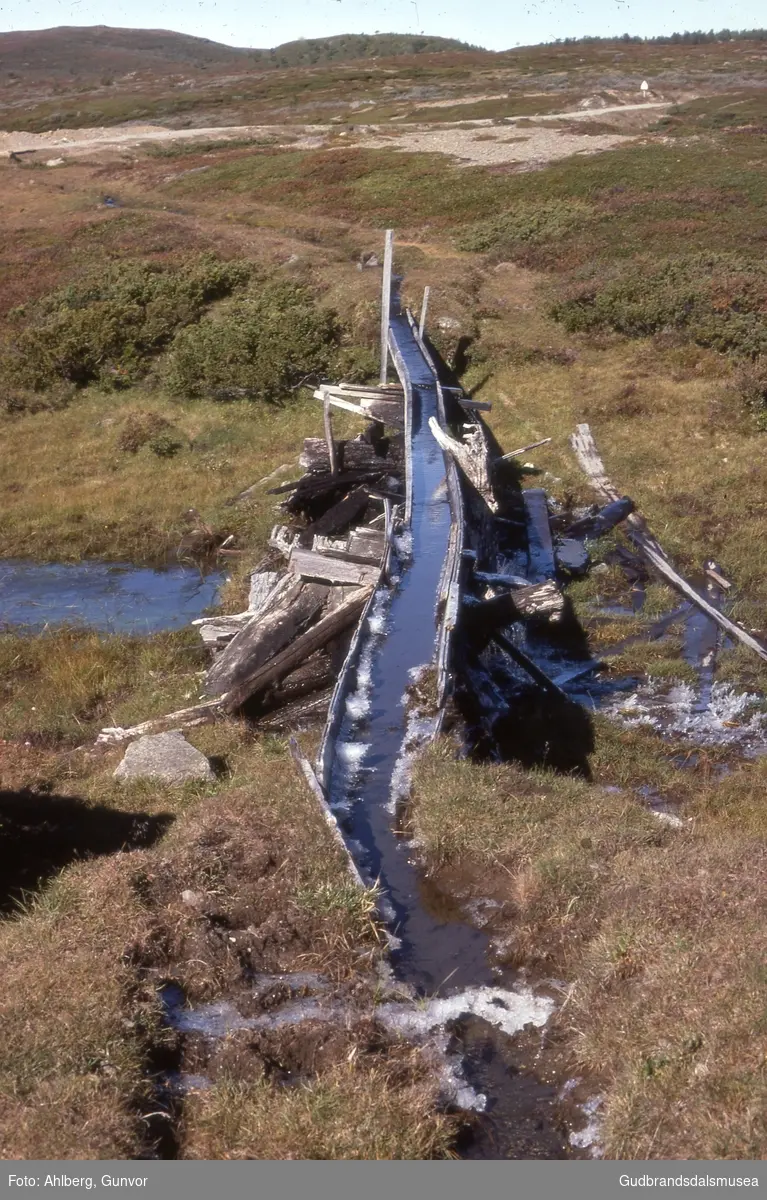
[204,578,328,696]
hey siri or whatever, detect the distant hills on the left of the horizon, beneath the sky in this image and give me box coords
[0,25,480,82]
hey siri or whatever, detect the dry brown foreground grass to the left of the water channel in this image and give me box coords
[0,705,453,1158]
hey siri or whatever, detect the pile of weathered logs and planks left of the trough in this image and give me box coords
[100,385,405,742]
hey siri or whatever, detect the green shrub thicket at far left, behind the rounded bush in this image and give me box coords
[4,254,251,391]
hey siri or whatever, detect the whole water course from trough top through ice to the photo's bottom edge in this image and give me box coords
[321,304,565,1158]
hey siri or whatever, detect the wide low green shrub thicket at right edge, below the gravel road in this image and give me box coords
[550,254,767,359]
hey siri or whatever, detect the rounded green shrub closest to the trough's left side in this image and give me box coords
[164,281,341,402]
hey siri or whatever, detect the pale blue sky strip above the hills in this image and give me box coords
[0,0,766,50]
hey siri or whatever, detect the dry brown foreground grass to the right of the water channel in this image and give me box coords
[412,722,767,1159]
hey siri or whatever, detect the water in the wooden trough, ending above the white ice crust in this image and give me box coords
[329,317,495,994]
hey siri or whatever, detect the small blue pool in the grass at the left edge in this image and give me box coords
[0,558,223,634]
